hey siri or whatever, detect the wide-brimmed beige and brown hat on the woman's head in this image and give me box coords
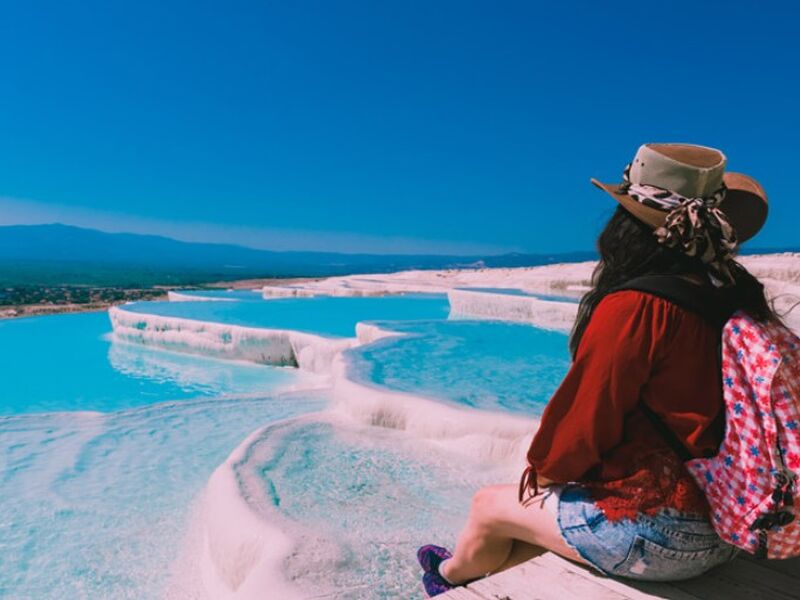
[592,144,768,243]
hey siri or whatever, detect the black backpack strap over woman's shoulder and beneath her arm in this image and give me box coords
[609,275,733,462]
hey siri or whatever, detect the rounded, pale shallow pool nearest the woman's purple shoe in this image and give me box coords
[240,421,504,598]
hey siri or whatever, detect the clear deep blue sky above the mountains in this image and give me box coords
[0,0,800,253]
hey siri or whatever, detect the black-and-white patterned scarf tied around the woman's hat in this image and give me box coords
[620,165,738,287]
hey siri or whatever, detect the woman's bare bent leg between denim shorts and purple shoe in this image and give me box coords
[442,485,584,583]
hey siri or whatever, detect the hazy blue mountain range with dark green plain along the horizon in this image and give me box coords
[0,224,797,286]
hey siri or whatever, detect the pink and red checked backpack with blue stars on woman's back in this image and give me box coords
[686,312,800,558]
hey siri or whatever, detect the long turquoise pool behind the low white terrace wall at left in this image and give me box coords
[122,294,449,337]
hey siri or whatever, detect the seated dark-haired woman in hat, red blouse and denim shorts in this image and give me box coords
[418,144,775,596]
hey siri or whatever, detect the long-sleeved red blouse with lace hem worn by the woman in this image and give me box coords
[528,291,725,520]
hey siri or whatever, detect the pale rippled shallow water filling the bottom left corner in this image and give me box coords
[0,394,324,600]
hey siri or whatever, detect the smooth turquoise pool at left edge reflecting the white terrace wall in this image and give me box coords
[0,312,297,415]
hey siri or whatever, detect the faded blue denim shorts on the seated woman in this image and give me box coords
[550,485,737,581]
